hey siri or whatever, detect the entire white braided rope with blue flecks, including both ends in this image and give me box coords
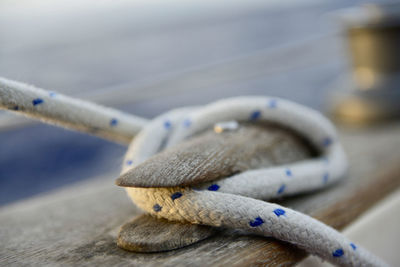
[0,78,385,266]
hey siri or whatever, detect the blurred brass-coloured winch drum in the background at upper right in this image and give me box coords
[332,3,400,123]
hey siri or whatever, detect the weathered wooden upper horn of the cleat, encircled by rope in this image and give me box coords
[116,123,316,187]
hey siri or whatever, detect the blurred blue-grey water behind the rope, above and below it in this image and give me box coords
[0,0,384,205]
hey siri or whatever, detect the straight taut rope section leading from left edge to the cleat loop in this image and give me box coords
[0,77,147,143]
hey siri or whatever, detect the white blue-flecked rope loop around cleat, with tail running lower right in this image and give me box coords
[121,97,381,266]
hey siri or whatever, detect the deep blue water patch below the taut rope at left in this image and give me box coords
[0,124,125,205]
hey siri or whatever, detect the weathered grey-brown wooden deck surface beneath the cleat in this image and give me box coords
[0,123,400,266]
